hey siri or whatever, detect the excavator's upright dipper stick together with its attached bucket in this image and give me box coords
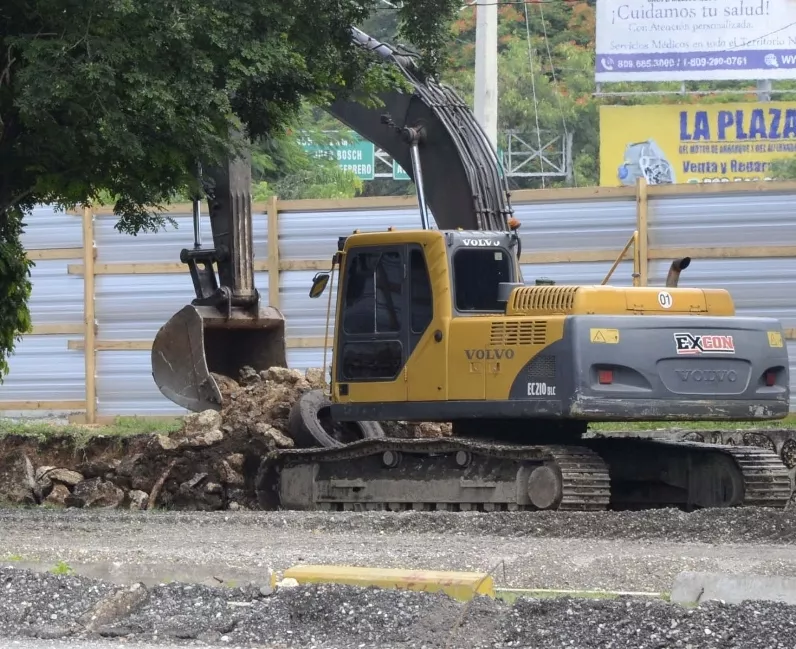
[152,151,287,412]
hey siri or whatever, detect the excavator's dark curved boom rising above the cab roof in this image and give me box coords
[327,27,512,231]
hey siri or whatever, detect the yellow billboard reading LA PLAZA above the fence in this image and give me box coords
[600,102,796,187]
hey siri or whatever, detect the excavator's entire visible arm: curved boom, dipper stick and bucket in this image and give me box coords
[151,27,512,411]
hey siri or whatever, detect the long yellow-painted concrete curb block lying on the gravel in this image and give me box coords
[284,565,495,601]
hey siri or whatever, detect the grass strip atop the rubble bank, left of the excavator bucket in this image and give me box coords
[0,417,181,440]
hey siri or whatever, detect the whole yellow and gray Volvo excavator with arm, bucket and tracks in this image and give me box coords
[152,29,790,511]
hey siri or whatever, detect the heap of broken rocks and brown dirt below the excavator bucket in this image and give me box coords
[0,367,451,510]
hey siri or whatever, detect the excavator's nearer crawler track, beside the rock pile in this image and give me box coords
[257,438,610,511]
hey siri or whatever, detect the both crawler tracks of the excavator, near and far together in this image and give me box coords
[257,438,791,511]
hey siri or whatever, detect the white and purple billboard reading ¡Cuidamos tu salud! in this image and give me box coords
[595,0,796,83]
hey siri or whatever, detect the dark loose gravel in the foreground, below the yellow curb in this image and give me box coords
[0,569,796,649]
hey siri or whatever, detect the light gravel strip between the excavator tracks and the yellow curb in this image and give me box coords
[0,509,796,592]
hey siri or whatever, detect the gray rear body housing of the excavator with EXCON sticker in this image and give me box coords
[510,315,790,421]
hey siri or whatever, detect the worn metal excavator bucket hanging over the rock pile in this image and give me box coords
[152,304,287,412]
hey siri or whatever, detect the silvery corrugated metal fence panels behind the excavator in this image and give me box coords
[0,180,796,416]
